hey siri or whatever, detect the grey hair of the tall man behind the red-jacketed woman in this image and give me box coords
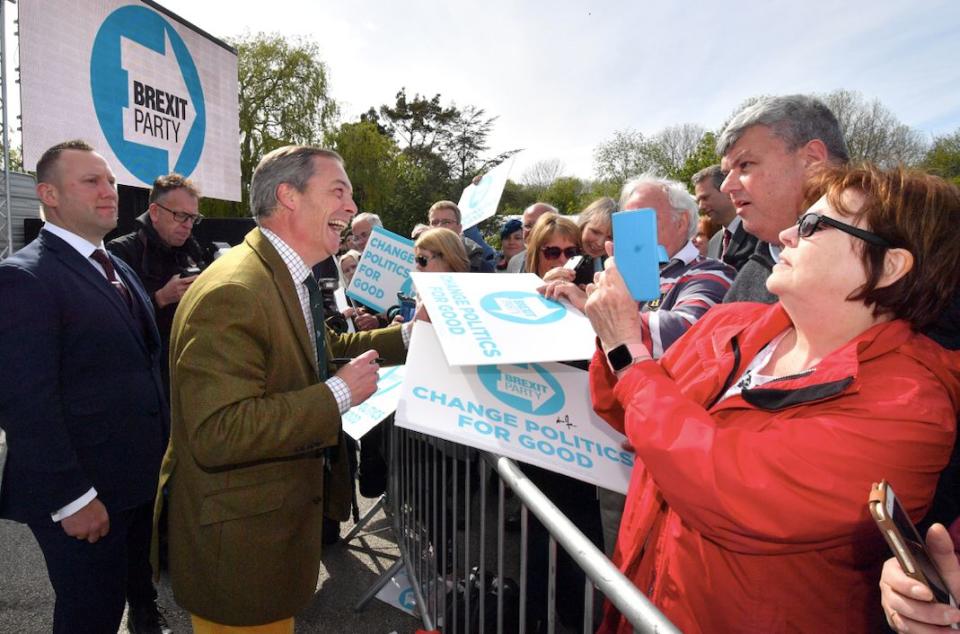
[717,95,850,163]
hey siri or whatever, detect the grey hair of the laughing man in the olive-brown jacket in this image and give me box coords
[250,145,343,224]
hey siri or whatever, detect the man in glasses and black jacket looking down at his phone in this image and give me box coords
[107,174,213,394]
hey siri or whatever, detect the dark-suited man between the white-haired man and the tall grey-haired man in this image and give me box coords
[690,165,757,271]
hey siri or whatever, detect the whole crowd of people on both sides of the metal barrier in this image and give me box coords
[0,90,960,634]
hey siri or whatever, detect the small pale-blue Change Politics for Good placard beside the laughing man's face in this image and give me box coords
[347,227,416,313]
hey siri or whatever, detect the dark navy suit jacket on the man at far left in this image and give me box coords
[0,231,169,522]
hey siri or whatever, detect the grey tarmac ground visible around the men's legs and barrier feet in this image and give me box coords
[0,454,419,634]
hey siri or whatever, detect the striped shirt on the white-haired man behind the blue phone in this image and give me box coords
[640,242,737,359]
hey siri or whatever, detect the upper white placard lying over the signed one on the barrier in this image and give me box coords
[411,272,596,365]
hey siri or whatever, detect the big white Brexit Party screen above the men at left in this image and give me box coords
[20,0,240,200]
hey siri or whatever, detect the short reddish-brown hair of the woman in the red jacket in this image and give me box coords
[806,165,960,330]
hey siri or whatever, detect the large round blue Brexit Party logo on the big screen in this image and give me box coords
[90,6,207,183]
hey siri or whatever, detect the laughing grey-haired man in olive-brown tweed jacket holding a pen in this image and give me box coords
[156,146,411,632]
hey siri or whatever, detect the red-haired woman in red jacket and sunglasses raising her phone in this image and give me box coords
[586,167,960,633]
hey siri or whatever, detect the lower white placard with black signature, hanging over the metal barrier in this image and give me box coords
[395,321,633,493]
